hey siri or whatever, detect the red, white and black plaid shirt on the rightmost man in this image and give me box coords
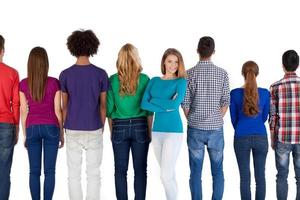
[269,73,300,144]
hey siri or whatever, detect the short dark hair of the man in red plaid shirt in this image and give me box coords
[282,50,299,72]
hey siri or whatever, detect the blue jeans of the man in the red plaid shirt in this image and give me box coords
[275,142,300,200]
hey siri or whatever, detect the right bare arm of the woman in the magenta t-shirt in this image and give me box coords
[54,90,65,148]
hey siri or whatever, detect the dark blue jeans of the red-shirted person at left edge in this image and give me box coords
[0,123,16,200]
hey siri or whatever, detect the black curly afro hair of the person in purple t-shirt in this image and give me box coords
[67,30,100,57]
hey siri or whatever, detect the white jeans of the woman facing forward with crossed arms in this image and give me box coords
[152,132,183,200]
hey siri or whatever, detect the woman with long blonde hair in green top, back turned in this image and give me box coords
[107,44,152,200]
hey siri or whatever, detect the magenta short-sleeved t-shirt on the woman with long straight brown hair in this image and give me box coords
[19,77,60,128]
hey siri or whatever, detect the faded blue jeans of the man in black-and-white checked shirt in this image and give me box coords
[187,127,224,200]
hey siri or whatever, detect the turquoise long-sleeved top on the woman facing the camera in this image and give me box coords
[142,77,186,133]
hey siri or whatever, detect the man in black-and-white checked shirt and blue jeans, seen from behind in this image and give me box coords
[182,37,230,200]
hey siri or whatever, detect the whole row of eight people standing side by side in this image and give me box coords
[0,30,300,200]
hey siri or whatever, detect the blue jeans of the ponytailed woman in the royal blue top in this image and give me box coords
[234,135,268,200]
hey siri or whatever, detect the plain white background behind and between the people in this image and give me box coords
[0,0,300,200]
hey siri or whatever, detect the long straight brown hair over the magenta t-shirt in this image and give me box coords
[27,47,49,102]
